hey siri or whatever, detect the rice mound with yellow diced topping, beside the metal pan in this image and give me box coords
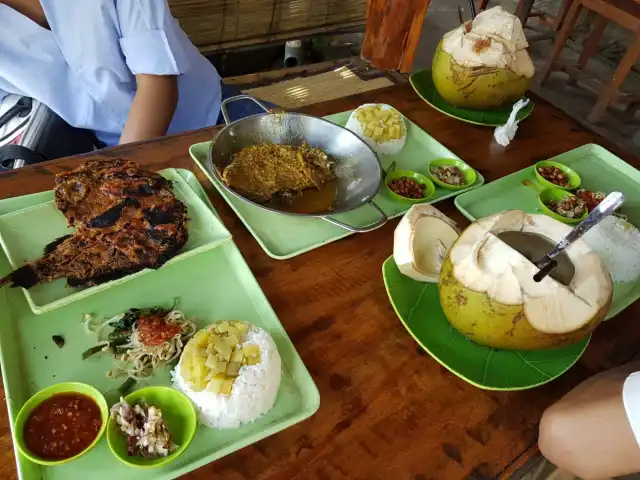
[345,103,407,155]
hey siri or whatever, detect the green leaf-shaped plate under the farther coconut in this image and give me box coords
[409,69,534,127]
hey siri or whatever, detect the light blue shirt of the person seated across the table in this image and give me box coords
[0,0,221,146]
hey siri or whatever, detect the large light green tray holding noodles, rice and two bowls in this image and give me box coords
[0,171,320,480]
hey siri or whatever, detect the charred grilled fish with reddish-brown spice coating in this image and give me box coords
[0,159,188,288]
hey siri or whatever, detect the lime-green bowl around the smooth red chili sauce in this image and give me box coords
[14,382,109,466]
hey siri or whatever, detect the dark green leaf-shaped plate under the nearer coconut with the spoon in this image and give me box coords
[382,257,591,390]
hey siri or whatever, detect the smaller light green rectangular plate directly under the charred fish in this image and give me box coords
[0,169,231,314]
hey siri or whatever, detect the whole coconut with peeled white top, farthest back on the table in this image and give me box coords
[432,6,535,109]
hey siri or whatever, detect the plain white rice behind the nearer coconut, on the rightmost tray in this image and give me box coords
[582,215,640,283]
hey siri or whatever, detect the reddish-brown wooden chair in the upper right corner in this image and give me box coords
[540,0,640,123]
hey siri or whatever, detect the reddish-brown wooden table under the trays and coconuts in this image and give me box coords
[0,86,640,480]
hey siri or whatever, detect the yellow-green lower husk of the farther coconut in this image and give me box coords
[432,42,531,110]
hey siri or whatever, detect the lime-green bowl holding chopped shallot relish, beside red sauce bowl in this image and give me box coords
[107,387,198,468]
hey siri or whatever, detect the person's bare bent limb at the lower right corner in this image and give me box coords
[538,362,640,480]
